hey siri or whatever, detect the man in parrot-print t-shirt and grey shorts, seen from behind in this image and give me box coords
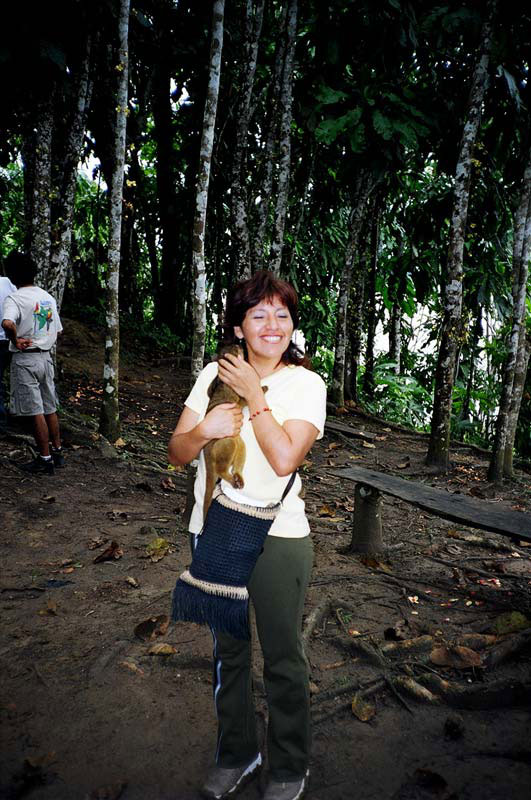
[2,252,64,475]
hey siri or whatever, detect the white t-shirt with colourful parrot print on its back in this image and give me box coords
[2,286,63,353]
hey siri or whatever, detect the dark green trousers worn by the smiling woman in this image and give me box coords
[203,536,313,781]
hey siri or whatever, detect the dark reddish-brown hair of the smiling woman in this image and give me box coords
[223,269,310,367]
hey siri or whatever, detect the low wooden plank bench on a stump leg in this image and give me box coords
[327,466,531,553]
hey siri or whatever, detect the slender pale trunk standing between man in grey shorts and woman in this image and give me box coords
[100,0,129,442]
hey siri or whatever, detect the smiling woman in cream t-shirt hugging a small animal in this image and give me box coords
[168,271,326,800]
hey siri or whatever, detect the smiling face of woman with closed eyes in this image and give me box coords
[234,295,293,363]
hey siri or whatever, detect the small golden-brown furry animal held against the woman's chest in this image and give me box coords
[203,344,245,519]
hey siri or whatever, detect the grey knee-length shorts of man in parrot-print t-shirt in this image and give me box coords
[9,352,57,417]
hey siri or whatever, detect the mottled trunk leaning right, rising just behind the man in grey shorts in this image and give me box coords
[47,37,93,309]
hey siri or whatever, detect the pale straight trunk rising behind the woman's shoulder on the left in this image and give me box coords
[191,0,225,385]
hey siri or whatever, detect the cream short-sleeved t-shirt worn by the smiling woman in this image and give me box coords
[185,362,326,538]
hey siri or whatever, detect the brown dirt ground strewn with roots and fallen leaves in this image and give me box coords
[0,320,531,800]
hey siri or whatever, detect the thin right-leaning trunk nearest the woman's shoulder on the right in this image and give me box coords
[330,172,374,406]
